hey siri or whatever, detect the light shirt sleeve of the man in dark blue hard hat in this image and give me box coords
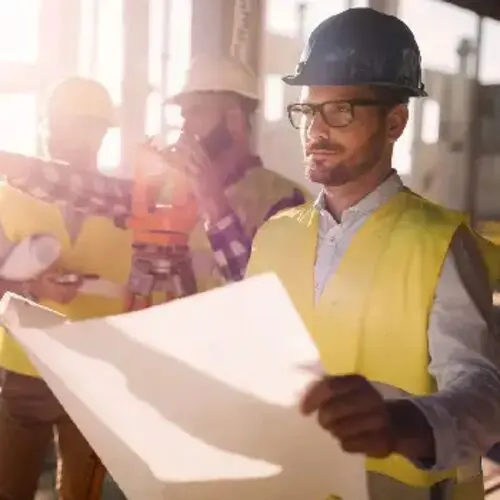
[412,229,500,469]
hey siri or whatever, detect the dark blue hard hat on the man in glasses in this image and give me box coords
[283,8,427,97]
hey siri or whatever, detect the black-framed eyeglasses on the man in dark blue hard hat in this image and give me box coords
[286,99,395,129]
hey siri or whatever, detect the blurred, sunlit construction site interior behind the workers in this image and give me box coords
[0,0,500,500]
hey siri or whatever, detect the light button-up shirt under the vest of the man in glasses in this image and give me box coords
[315,174,500,469]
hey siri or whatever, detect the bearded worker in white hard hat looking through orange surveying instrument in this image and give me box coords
[147,54,305,291]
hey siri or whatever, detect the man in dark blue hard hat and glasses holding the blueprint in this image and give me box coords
[247,9,500,500]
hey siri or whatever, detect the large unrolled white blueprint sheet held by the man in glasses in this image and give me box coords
[1,275,368,500]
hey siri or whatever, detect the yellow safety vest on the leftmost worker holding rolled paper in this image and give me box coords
[0,186,132,376]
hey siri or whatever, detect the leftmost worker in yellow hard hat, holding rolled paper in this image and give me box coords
[0,78,131,500]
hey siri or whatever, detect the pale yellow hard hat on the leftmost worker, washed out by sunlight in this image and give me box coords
[45,77,117,127]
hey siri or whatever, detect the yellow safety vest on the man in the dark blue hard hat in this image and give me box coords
[247,191,498,500]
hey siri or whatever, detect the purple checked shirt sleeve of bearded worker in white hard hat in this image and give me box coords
[207,189,305,282]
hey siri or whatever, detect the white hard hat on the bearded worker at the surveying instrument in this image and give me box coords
[166,54,259,104]
